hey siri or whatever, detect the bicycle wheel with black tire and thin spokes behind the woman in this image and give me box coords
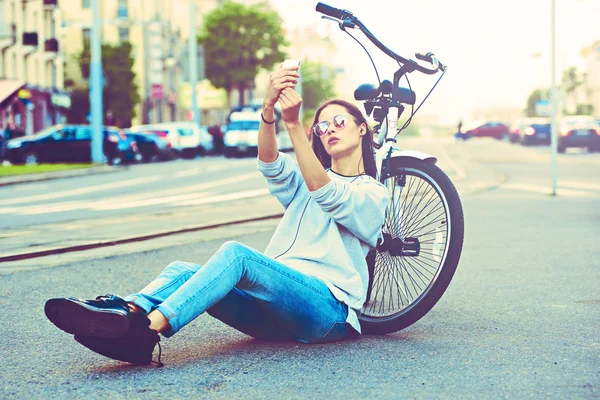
[359,158,464,335]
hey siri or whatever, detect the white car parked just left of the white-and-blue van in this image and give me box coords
[129,121,214,158]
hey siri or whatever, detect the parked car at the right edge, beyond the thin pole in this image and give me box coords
[558,115,600,153]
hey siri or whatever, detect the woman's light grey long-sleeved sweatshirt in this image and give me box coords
[258,153,390,332]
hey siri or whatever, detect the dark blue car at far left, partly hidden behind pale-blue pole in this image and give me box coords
[5,125,141,165]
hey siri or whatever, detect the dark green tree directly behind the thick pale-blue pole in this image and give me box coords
[79,42,140,128]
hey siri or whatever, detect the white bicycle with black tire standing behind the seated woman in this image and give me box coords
[316,3,464,334]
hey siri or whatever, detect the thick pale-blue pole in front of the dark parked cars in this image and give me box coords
[90,0,104,164]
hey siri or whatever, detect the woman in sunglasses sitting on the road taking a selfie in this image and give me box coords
[45,67,389,364]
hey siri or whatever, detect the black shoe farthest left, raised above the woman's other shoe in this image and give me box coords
[44,294,134,339]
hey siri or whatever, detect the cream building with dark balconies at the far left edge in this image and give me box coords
[0,0,71,135]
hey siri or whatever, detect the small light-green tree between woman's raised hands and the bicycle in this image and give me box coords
[300,60,335,115]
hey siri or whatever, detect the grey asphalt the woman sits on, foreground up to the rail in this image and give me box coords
[0,137,600,399]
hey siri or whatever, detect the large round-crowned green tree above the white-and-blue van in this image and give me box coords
[198,1,287,104]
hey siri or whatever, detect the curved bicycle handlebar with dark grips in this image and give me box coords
[316,2,446,75]
